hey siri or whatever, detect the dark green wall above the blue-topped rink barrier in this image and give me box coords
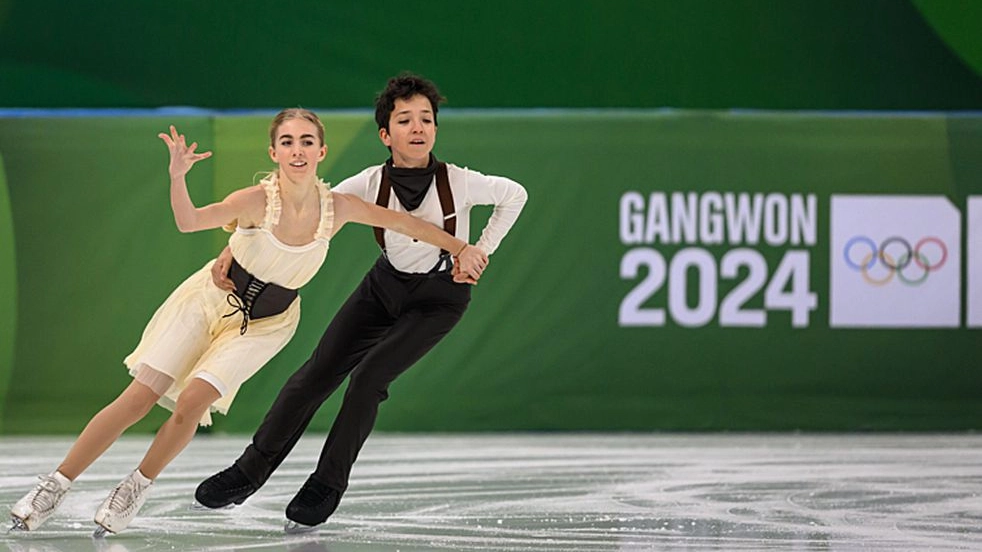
[0,0,982,110]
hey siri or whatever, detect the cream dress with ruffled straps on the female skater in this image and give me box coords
[123,173,334,425]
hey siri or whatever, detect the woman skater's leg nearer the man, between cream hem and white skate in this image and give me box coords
[140,378,221,479]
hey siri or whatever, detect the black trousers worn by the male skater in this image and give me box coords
[235,257,470,492]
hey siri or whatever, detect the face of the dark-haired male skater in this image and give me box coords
[379,94,436,168]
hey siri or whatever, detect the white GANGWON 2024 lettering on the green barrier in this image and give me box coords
[618,191,818,328]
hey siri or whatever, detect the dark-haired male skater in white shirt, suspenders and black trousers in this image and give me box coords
[195,73,528,531]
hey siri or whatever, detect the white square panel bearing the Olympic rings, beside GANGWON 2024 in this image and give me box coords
[829,195,961,328]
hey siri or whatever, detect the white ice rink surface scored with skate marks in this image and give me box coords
[0,434,982,552]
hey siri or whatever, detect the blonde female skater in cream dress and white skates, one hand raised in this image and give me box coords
[11,109,488,536]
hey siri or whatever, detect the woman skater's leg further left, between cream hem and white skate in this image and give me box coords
[58,380,160,481]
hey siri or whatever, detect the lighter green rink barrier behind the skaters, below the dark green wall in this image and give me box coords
[0,110,982,433]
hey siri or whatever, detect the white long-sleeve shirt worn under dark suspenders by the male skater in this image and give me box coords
[333,163,528,273]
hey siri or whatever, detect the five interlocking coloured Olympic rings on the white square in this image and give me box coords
[842,236,948,286]
